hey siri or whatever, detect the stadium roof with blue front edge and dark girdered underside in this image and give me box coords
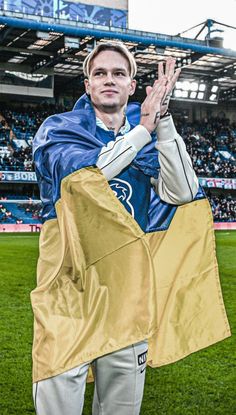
[0,12,236,101]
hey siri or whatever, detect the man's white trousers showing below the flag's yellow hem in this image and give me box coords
[33,341,148,415]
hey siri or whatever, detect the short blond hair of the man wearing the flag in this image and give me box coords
[83,41,137,78]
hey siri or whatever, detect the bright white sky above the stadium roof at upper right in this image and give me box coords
[129,0,236,49]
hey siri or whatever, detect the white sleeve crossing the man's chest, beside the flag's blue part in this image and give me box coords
[96,125,151,180]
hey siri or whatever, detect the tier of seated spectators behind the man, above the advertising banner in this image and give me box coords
[0,107,236,178]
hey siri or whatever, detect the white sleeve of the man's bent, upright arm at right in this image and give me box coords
[151,115,199,205]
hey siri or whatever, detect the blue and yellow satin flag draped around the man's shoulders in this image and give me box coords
[31,96,230,382]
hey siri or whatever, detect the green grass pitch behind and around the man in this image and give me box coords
[0,231,236,415]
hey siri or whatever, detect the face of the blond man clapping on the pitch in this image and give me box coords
[85,50,136,113]
